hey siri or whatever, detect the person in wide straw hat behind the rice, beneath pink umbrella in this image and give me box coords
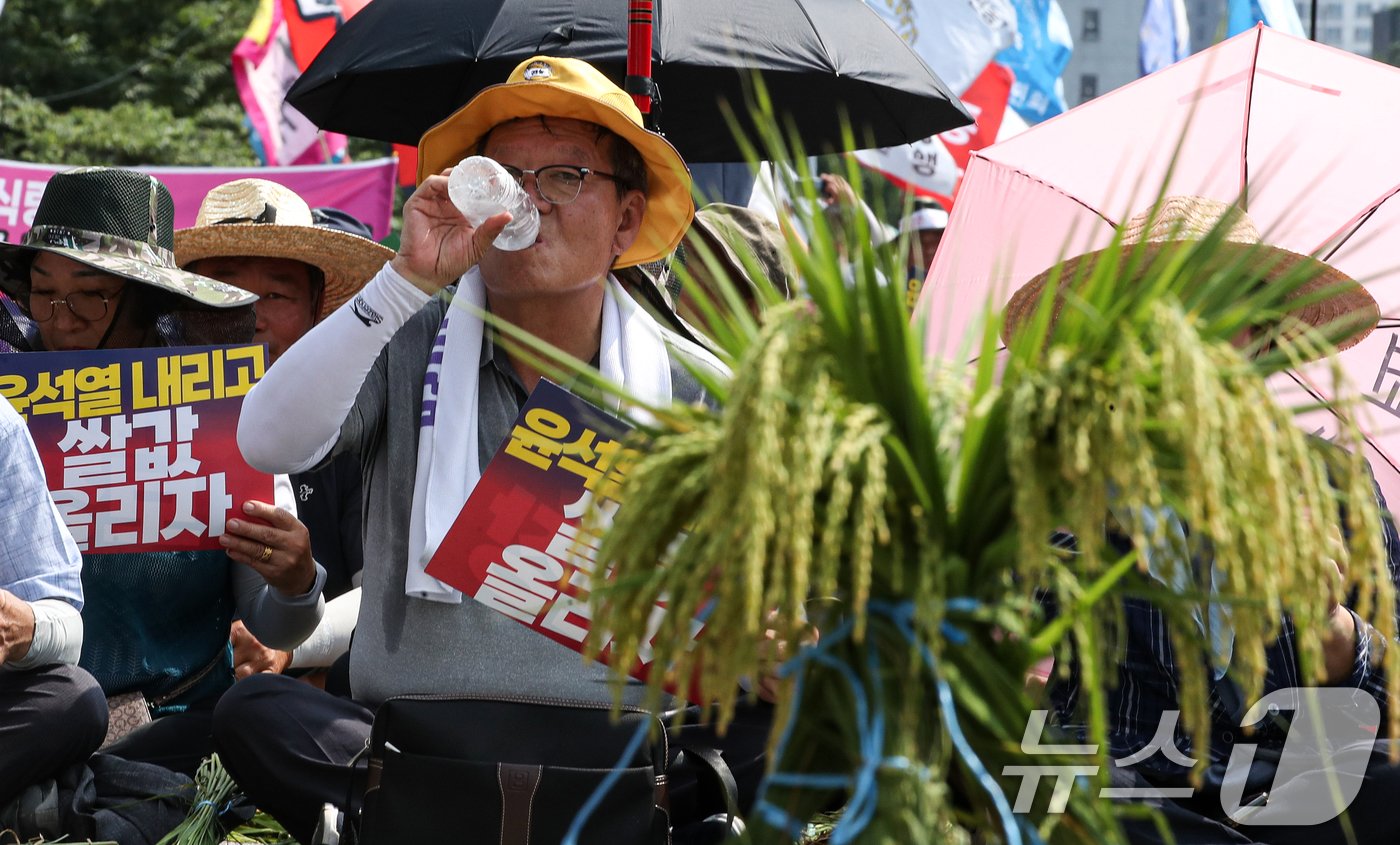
[1024,197,1400,845]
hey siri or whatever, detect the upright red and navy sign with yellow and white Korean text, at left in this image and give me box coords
[0,346,273,554]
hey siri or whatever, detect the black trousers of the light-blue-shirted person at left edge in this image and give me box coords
[0,663,106,807]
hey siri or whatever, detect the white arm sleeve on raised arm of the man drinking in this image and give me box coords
[238,264,428,473]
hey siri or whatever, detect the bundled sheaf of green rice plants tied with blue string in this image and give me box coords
[576,91,1400,844]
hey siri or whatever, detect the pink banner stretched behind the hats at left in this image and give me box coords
[0,158,398,243]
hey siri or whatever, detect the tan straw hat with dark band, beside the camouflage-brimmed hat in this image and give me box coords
[175,179,393,319]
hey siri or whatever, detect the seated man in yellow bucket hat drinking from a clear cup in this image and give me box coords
[216,57,767,841]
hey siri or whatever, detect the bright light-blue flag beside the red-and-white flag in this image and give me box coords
[997,0,1074,123]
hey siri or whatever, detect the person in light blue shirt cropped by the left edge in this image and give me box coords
[0,397,106,810]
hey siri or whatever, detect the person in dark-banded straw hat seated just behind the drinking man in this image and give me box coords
[175,179,393,693]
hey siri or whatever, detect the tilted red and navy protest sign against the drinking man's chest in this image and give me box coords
[427,379,703,680]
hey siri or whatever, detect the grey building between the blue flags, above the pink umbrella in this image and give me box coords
[1060,0,1142,106]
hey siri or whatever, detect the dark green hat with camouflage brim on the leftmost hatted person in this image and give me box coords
[0,168,256,308]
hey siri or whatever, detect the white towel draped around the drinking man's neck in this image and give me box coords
[403,269,671,604]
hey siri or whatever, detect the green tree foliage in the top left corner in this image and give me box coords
[0,0,258,165]
